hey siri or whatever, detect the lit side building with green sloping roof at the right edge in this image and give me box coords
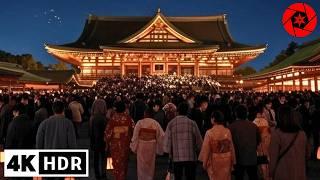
[243,39,320,92]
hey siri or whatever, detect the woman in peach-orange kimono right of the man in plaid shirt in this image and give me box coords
[199,111,236,180]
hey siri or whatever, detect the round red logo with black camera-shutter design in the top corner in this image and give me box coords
[282,3,317,37]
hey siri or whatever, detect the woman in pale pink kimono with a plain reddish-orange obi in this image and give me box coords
[130,108,164,180]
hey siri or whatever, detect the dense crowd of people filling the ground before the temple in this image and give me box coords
[0,76,320,180]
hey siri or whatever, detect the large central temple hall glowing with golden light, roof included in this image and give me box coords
[45,10,266,85]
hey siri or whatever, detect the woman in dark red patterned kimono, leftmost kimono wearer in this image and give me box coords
[104,102,134,180]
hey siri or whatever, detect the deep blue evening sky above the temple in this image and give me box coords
[0,0,320,69]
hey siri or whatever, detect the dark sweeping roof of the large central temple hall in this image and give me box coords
[47,12,265,51]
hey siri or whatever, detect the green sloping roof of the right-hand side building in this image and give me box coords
[247,39,320,78]
